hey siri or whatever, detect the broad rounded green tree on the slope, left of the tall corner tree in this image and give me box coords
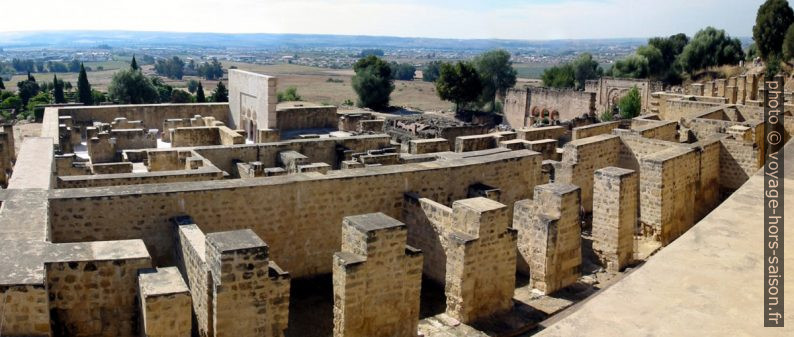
[681,27,744,74]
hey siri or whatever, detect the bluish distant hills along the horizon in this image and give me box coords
[0,31,646,50]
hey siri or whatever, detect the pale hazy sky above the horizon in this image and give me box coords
[0,0,763,39]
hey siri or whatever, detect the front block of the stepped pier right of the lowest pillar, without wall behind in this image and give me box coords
[206,229,289,337]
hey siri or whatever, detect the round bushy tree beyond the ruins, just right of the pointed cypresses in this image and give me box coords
[108,69,160,104]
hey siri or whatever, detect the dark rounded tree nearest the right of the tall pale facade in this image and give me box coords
[352,55,394,109]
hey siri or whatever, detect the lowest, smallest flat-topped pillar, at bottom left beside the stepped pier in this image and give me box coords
[138,267,192,337]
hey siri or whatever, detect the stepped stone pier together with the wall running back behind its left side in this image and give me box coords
[173,216,290,337]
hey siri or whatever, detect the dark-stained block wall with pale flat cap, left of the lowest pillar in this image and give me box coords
[45,240,152,336]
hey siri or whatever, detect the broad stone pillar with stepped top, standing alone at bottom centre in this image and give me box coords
[333,213,422,337]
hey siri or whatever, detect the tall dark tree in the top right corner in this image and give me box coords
[753,0,794,62]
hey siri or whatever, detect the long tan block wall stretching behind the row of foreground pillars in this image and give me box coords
[49,150,541,277]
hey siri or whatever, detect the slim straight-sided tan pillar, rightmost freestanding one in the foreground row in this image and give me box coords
[592,167,639,272]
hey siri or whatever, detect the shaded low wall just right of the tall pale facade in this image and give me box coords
[270,106,339,131]
